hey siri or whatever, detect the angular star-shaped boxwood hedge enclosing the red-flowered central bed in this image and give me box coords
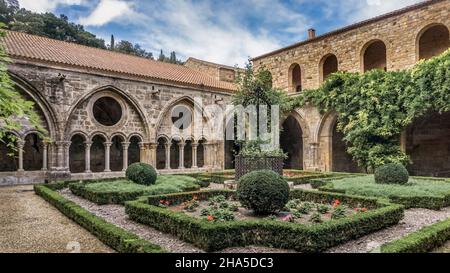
[125,190,404,253]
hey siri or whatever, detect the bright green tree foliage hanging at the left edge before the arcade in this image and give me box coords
[0,24,45,145]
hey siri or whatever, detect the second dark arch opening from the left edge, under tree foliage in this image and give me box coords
[23,134,44,171]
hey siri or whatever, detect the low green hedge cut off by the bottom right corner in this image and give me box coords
[381,219,450,253]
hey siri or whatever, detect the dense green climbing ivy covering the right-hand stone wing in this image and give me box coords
[289,50,450,172]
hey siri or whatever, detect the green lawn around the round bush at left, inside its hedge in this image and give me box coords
[85,175,200,195]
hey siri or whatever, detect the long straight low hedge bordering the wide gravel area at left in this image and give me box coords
[34,182,165,253]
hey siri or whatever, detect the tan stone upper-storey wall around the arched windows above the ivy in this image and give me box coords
[253,0,450,92]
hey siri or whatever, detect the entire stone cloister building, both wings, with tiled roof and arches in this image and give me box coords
[0,0,450,185]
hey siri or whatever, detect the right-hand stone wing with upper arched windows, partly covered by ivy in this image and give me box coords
[253,0,450,176]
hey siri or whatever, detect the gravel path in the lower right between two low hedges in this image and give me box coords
[328,207,450,253]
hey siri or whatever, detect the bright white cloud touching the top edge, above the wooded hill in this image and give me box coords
[79,0,139,27]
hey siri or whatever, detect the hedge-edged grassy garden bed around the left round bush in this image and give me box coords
[69,175,200,205]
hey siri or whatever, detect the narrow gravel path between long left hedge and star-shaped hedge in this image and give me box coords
[61,186,289,253]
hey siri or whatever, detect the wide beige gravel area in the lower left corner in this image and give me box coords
[0,186,114,253]
